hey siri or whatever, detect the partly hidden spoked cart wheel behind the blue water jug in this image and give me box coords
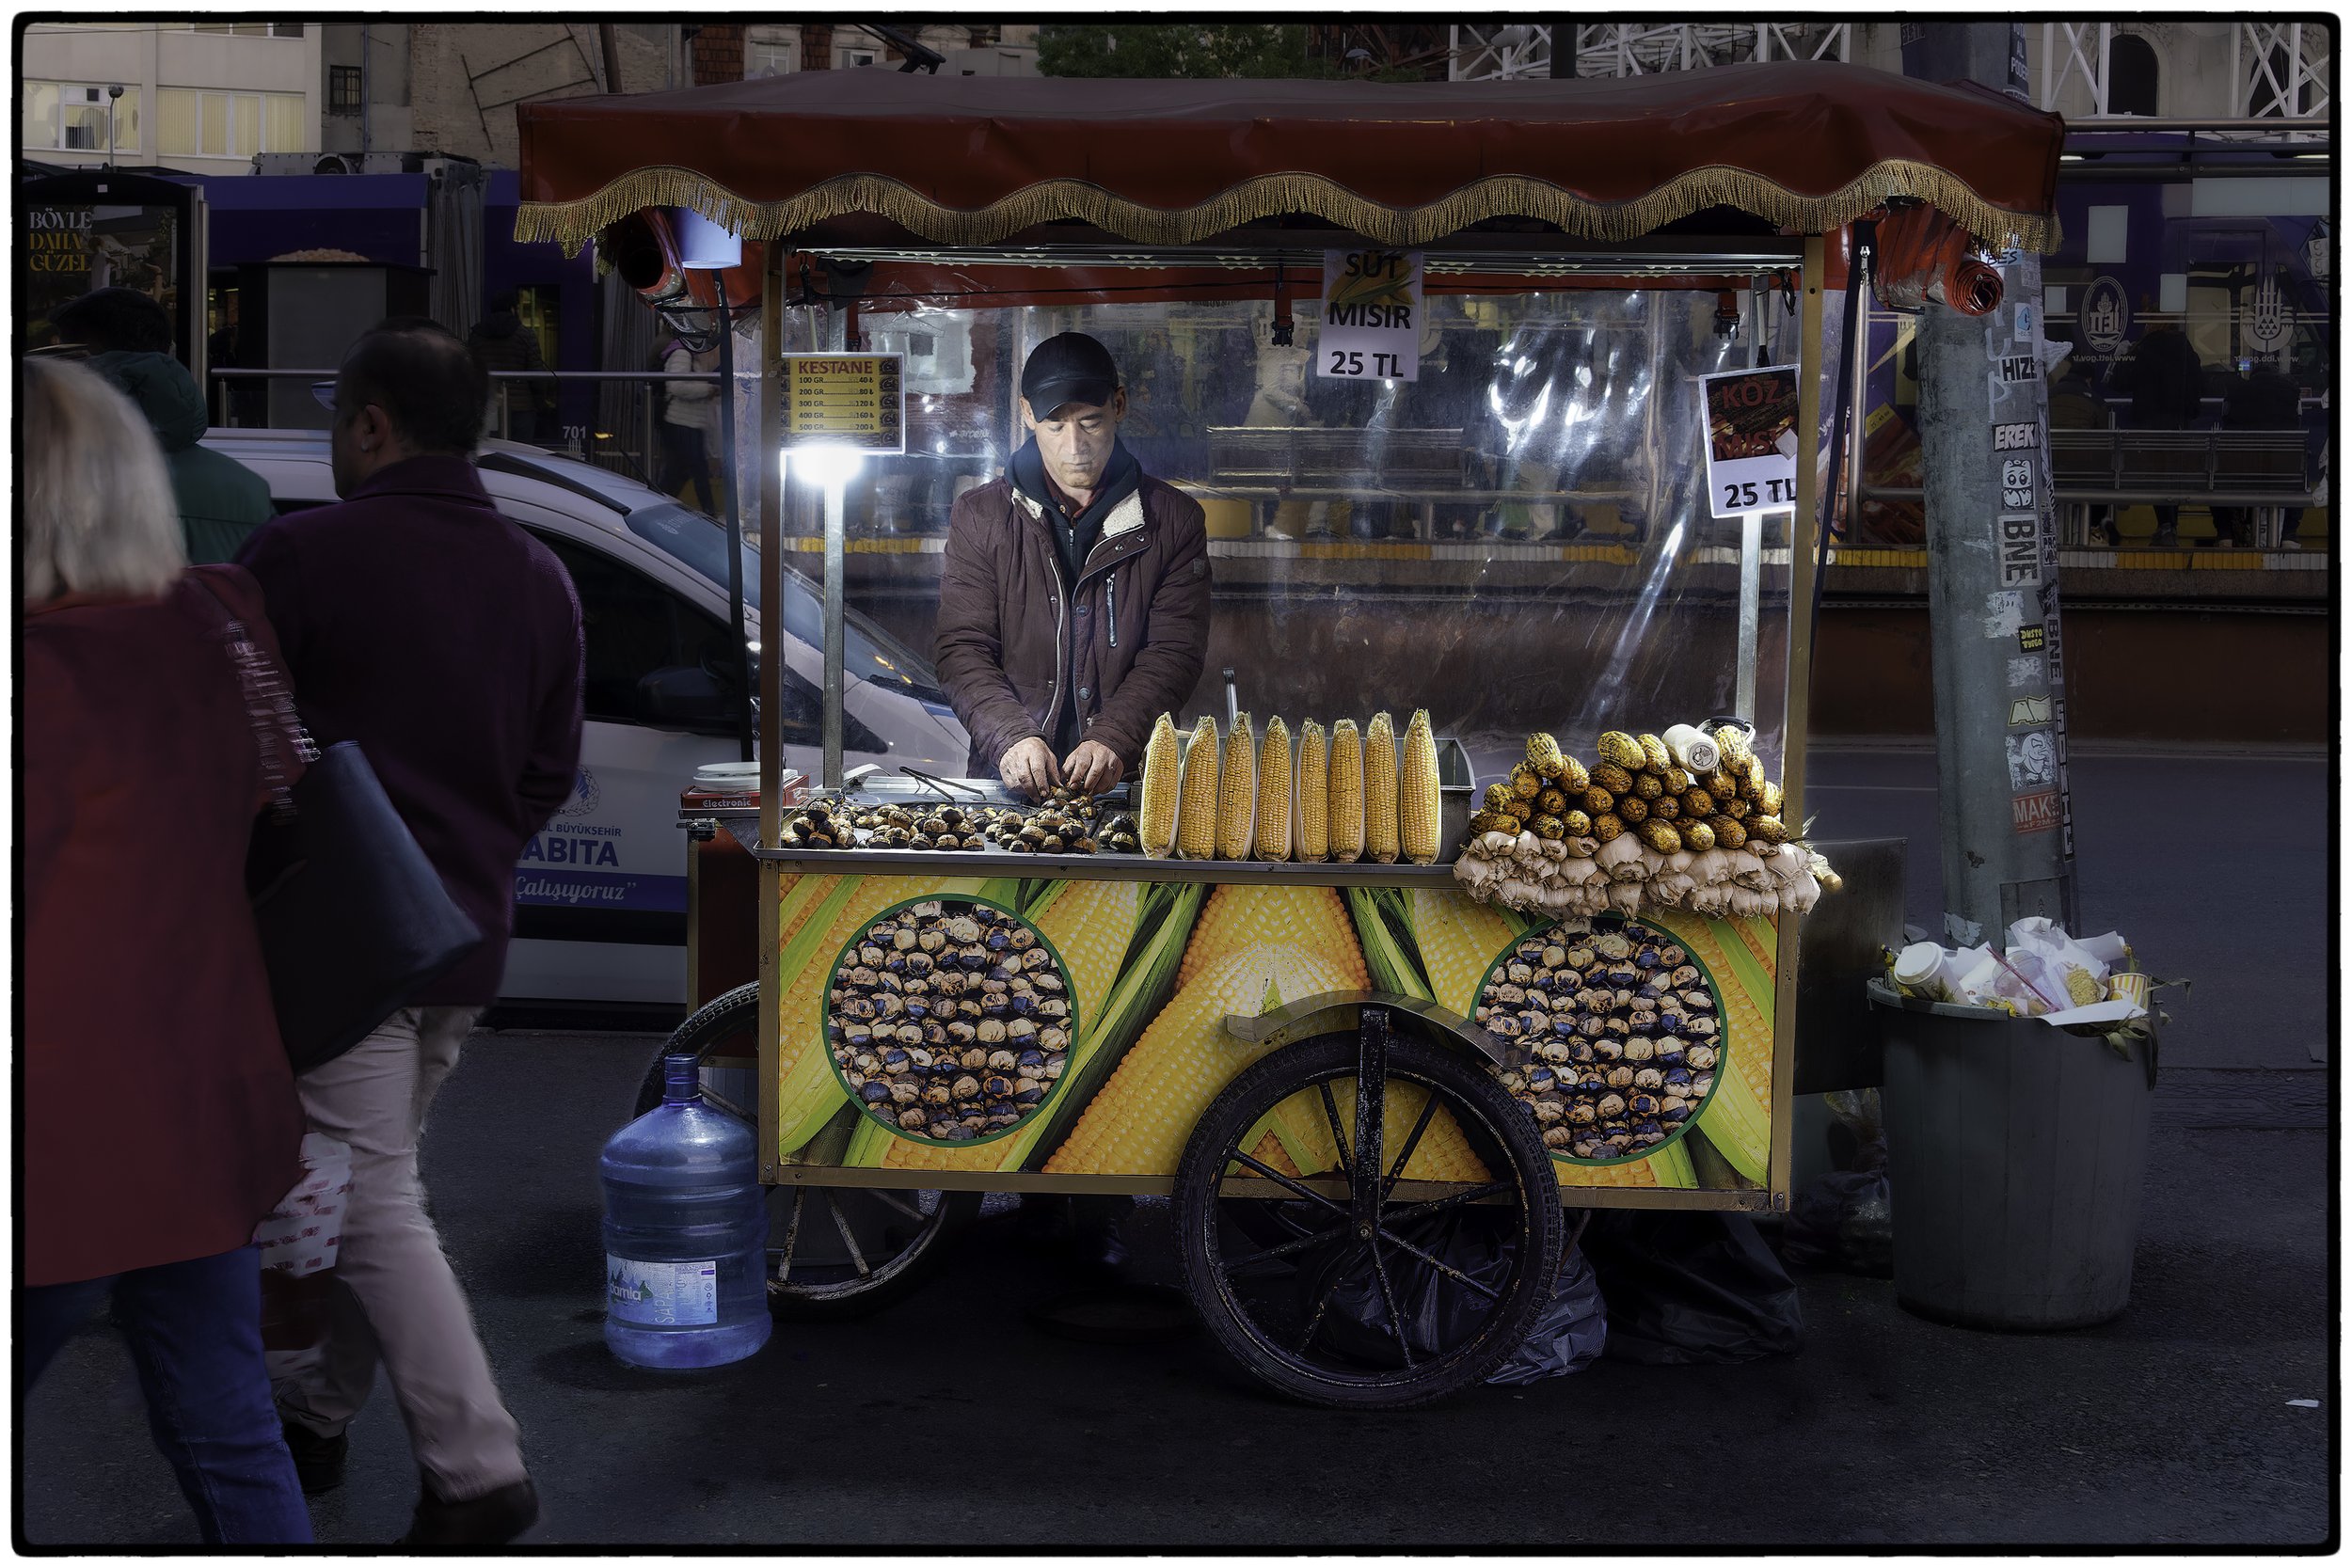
[638,985,981,1322]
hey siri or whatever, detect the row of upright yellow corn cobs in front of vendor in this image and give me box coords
[1136,710,1442,865]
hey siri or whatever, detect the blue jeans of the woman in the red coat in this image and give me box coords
[17,1246,310,1547]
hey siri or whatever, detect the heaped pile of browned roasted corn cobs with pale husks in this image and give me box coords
[1454,724,1828,919]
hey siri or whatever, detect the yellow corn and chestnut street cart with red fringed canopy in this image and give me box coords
[517,63,2058,1406]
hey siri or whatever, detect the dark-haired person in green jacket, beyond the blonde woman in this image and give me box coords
[52,289,278,566]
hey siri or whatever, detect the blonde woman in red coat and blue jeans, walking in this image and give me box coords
[17,359,310,1544]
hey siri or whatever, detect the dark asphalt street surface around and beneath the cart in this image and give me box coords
[19,750,2338,1549]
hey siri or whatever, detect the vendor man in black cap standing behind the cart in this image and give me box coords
[936,331,1209,800]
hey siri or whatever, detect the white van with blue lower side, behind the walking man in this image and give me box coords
[205,430,969,1006]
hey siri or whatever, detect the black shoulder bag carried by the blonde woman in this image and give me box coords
[205,583,483,1072]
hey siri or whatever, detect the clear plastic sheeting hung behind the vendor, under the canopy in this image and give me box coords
[771,273,1837,799]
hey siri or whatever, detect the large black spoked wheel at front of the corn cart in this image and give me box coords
[1176,1029,1565,1411]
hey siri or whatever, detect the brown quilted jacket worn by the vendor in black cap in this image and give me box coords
[936,475,1209,778]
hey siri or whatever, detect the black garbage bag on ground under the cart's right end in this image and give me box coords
[1579,1209,1804,1366]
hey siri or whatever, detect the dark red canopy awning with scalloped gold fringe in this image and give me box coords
[516,61,2065,249]
